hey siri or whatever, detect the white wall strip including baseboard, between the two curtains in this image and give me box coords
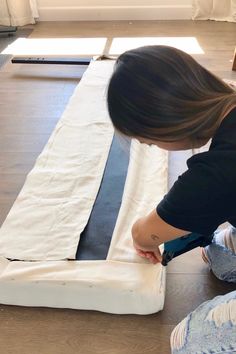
[37,0,192,21]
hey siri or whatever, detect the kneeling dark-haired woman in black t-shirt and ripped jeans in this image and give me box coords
[107,46,236,354]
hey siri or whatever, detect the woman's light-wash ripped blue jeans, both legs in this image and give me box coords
[170,226,236,354]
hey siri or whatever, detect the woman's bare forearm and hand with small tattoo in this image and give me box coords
[132,210,190,263]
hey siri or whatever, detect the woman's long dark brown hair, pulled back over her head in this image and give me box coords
[107,45,236,142]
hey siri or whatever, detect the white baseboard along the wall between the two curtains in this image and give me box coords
[39,5,192,21]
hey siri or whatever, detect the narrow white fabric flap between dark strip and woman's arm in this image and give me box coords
[107,140,168,262]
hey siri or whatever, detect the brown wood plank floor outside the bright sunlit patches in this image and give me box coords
[0,21,236,354]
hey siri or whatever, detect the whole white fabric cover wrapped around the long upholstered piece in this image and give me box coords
[0,61,168,314]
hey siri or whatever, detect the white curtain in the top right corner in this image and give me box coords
[192,0,236,22]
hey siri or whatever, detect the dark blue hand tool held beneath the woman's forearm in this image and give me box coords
[161,233,214,266]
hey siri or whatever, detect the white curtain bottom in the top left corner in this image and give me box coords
[0,0,39,26]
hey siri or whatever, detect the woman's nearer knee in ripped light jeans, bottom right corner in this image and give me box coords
[170,291,236,354]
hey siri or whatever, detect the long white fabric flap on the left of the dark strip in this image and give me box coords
[0,62,113,260]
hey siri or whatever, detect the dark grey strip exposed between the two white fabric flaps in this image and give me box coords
[76,136,129,260]
